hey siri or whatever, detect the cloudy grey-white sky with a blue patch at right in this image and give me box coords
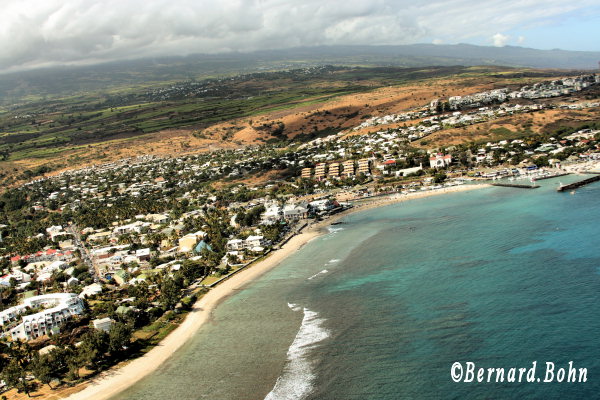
[0,0,600,71]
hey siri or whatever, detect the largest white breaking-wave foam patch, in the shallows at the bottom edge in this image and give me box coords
[265,303,329,400]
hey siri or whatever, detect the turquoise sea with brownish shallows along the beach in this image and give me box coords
[118,177,600,400]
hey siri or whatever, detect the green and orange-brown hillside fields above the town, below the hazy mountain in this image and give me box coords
[0,62,597,188]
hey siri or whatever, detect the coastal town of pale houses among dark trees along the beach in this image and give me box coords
[0,74,600,394]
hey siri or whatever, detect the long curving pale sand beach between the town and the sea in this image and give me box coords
[64,184,490,400]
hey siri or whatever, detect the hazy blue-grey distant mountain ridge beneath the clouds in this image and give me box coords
[0,44,600,104]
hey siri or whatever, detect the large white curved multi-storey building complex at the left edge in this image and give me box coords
[0,293,83,340]
